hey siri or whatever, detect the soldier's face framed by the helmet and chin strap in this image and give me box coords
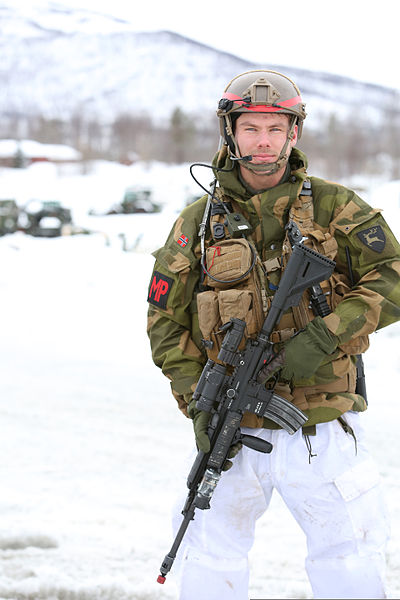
[235,113,297,164]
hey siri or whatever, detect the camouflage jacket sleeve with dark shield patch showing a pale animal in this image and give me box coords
[324,190,400,343]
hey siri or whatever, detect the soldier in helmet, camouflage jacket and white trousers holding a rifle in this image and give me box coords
[148,70,400,600]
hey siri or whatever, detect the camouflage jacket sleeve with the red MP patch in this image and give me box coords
[147,204,206,414]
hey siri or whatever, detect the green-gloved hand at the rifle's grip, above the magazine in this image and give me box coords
[258,317,339,383]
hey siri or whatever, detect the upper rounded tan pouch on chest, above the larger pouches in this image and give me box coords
[205,238,252,289]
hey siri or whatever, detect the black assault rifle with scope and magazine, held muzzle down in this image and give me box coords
[157,221,335,583]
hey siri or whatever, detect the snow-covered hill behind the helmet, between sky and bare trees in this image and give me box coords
[0,0,394,126]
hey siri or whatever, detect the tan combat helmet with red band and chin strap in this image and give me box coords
[217,69,306,174]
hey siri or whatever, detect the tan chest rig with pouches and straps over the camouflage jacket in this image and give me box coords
[197,179,368,361]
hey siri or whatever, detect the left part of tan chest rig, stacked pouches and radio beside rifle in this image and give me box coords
[197,188,268,362]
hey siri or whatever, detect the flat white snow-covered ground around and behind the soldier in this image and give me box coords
[0,163,400,600]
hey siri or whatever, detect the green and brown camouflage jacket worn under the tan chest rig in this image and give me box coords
[148,149,400,428]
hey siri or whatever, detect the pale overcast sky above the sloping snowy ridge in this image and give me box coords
[16,0,400,90]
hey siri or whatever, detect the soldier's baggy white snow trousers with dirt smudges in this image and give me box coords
[173,413,389,600]
